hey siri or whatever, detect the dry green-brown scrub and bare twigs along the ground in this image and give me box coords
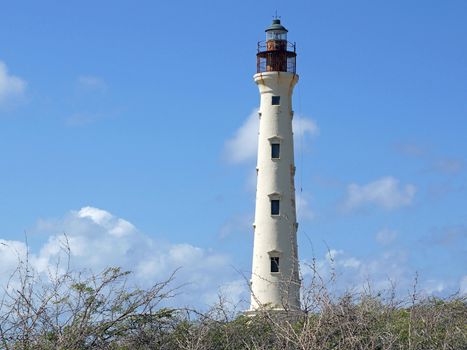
[0,246,467,350]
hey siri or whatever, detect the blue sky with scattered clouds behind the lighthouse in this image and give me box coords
[0,0,467,304]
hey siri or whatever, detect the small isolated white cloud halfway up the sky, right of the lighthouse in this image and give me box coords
[344,176,416,210]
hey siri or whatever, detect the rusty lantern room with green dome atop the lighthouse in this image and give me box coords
[256,18,297,73]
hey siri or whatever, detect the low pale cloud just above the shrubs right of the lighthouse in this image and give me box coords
[300,249,460,300]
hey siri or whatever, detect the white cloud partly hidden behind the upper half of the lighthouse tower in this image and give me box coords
[225,109,319,164]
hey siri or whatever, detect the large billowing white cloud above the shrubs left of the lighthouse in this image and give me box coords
[0,207,247,306]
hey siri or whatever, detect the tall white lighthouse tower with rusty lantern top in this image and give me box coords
[250,19,300,311]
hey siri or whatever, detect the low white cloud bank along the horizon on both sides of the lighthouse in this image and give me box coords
[0,207,460,308]
